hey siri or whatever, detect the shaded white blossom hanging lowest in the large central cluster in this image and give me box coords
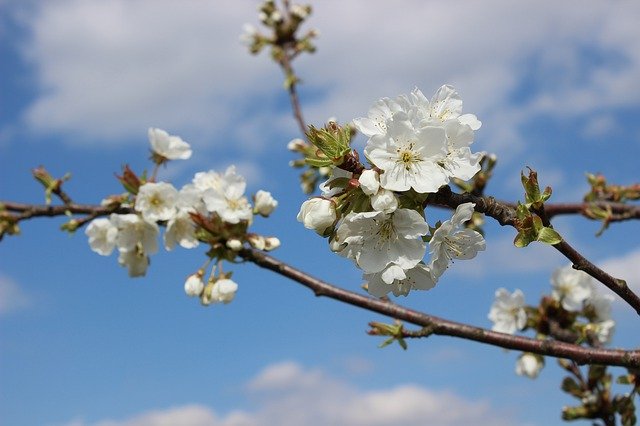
[362,263,436,297]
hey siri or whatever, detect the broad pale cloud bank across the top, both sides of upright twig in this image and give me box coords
[8,0,640,158]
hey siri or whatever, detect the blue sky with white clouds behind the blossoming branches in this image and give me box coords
[0,0,640,426]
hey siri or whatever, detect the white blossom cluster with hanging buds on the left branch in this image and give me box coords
[85,128,280,305]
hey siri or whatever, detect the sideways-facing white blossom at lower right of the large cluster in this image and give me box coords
[429,203,486,277]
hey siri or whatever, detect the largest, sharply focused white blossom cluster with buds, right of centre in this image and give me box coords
[298,85,485,297]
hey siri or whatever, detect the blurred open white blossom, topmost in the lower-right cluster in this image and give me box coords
[551,265,593,312]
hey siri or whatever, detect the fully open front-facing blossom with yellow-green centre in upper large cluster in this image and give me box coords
[364,113,449,193]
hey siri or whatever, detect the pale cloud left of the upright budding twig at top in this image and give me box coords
[18,0,275,140]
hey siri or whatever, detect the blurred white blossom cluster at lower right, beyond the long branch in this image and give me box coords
[488,265,615,378]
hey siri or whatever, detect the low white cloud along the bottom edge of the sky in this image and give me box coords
[61,362,516,426]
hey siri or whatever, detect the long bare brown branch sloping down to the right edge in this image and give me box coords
[239,249,640,367]
